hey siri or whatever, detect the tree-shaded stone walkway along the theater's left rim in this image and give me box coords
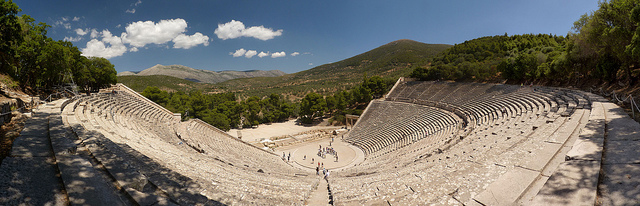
[0,100,129,205]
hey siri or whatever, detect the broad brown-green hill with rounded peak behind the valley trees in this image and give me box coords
[216,39,452,98]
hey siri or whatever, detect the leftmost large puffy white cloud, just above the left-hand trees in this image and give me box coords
[82,29,127,59]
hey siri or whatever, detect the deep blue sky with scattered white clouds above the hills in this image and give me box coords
[14,0,597,73]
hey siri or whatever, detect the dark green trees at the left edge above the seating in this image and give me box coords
[0,0,117,94]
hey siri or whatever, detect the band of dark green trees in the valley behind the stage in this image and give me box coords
[142,76,394,131]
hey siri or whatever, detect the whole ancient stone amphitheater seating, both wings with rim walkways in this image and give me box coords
[0,78,640,205]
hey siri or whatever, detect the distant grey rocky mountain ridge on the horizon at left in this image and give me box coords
[118,64,286,83]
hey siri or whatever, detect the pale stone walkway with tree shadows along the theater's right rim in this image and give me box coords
[531,98,640,205]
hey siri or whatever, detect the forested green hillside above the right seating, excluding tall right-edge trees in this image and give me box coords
[413,34,567,81]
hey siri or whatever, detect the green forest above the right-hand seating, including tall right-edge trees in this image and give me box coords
[410,0,640,85]
